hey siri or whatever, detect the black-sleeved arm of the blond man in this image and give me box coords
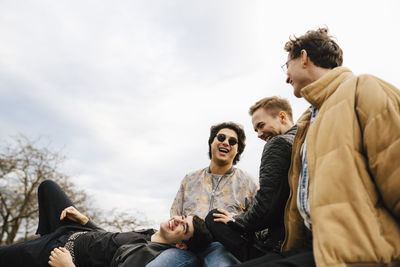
[234,136,292,231]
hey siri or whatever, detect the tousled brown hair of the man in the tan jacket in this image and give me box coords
[285,28,343,69]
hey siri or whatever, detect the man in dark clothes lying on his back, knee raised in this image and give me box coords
[0,180,212,267]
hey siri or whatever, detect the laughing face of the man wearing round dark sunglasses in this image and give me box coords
[211,128,239,166]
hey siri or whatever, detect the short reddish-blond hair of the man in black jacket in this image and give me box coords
[249,96,293,122]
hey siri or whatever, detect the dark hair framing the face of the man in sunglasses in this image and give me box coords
[208,122,246,165]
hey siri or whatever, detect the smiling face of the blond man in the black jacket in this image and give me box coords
[251,108,286,142]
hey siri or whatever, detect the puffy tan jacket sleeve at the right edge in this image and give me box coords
[356,75,400,219]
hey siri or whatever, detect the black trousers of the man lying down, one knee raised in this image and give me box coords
[0,180,81,267]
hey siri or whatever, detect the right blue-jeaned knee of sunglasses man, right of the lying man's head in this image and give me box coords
[200,242,240,267]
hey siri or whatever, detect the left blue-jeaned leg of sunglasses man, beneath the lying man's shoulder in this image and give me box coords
[146,248,201,267]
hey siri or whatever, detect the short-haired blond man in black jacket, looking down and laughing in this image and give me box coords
[206,96,297,261]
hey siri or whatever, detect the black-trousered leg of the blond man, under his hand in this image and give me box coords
[205,209,264,261]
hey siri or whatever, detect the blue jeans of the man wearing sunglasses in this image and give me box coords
[146,242,240,267]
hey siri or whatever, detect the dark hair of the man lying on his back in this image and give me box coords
[182,215,213,252]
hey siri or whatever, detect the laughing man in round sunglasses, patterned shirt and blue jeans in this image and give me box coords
[148,122,258,267]
